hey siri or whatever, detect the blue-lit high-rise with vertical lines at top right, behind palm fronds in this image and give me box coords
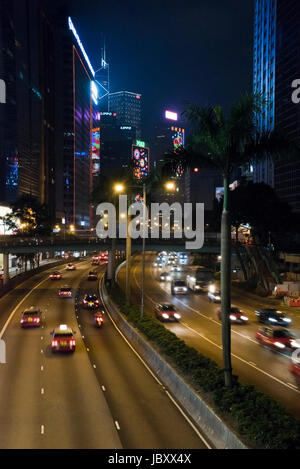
[253,0,300,211]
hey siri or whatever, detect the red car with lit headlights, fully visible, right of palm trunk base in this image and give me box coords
[255,326,297,352]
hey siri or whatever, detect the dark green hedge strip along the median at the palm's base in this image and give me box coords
[109,285,300,449]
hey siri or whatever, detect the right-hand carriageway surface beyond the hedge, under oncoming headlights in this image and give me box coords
[120,254,300,417]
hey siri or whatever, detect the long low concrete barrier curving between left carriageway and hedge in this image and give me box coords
[101,283,247,449]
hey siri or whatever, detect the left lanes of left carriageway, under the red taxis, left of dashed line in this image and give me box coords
[0,262,122,448]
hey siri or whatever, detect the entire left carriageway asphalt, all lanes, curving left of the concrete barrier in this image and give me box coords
[0,260,210,449]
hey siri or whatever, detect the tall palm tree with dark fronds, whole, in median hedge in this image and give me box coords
[166,94,299,387]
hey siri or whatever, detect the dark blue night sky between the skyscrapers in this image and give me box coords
[71,0,253,137]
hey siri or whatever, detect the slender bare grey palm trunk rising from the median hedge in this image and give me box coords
[221,175,232,387]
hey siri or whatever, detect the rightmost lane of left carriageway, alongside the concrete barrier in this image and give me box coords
[76,266,210,449]
